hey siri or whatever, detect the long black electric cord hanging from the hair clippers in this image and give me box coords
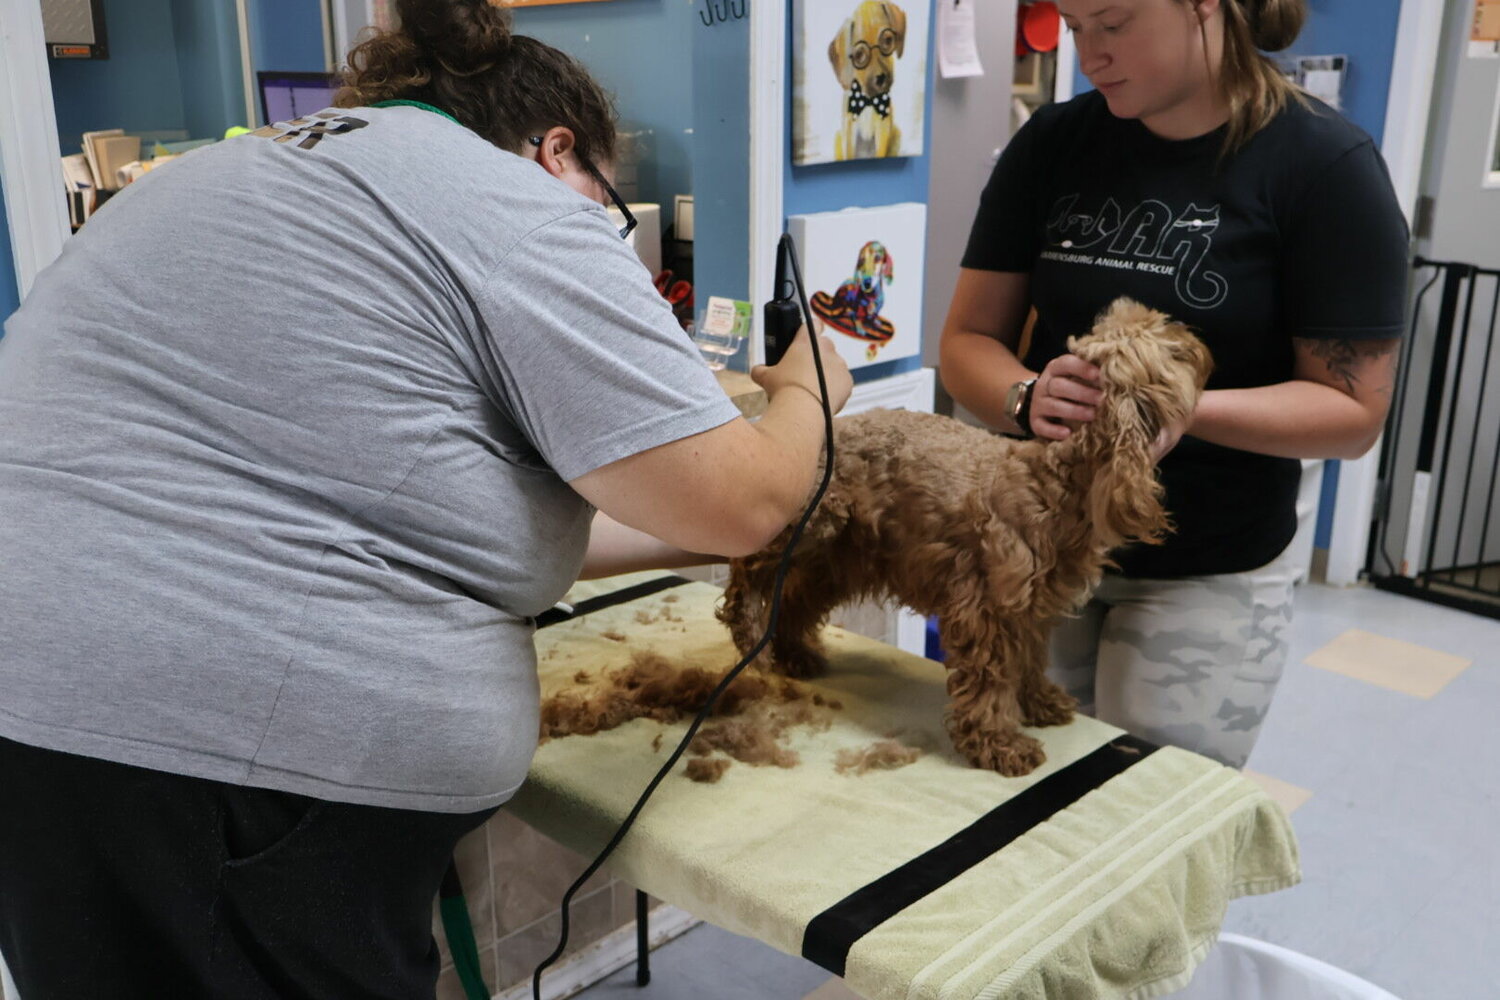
[531,232,834,1000]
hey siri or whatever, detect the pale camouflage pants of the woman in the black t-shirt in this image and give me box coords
[1047,552,1296,768]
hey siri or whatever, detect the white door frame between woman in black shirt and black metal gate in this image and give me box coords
[1326,0,1445,586]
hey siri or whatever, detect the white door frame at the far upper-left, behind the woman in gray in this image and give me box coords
[0,1,69,298]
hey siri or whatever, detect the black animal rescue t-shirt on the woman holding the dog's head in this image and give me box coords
[963,91,1407,577]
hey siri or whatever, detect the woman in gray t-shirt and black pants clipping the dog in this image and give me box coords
[0,0,851,1000]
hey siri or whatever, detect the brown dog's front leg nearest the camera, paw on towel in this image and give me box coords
[939,616,1047,777]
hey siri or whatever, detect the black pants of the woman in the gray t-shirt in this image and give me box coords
[0,739,494,1000]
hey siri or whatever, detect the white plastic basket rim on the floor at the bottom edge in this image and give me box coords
[1166,934,1397,1000]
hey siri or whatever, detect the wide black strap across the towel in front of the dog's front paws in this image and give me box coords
[803,735,1157,976]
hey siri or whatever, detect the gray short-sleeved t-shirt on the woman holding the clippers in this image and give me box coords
[0,106,737,811]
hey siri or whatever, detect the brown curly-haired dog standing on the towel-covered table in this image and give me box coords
[719,298,1212,775]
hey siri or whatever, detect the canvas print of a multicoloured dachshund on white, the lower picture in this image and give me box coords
[788,202,927,369]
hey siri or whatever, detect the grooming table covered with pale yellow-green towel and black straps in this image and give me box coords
[510,573,1301,1000]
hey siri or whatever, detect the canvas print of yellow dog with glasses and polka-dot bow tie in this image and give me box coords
[792,0,929,165]
